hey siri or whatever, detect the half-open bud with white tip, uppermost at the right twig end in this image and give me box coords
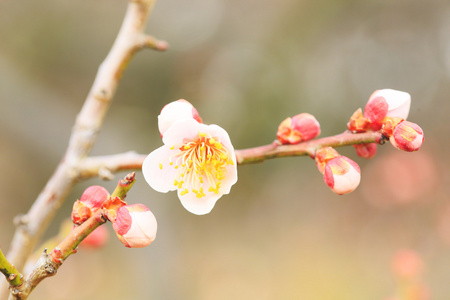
[364,89,411,130]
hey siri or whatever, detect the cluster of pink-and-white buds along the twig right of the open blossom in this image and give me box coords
[277,89,424,195]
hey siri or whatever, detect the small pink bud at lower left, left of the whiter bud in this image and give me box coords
[72,185,109,225]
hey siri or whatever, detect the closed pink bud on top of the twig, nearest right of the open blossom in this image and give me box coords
[277,113,320,144]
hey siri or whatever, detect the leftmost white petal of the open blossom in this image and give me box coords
[142,146,179,193]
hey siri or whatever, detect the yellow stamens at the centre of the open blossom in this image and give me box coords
[166,132,234,198]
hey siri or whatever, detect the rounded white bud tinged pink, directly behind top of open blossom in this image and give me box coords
[158,99,202,136]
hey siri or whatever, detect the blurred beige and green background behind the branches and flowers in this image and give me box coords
[0,0,450,300]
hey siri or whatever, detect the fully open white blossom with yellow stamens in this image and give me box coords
[142,118,237,215]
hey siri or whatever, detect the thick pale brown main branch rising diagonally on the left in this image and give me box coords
[0,0,164,298]
